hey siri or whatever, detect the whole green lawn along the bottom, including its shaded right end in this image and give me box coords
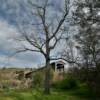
[0,89,100,100]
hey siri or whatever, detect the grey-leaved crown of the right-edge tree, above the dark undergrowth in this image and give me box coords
[75,0,100,69]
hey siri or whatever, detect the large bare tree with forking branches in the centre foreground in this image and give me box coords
[14,0,70,94]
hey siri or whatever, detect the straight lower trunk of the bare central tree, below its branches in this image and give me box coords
[44,60,50,94]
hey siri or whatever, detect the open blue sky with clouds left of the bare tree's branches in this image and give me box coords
[0,0,64,67]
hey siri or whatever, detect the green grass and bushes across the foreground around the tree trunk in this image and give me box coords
[0,69,100,100]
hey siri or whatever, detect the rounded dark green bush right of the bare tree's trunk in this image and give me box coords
[52,78,78,90]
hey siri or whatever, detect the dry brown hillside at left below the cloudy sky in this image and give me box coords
[0,68,34,88]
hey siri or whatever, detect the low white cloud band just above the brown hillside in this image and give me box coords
[0,55,37,68]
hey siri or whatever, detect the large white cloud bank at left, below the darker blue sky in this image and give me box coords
[0,20,43,67]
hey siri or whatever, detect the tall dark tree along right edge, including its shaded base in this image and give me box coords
[74,0,100,93]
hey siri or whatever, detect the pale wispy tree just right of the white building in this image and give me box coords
[61,38,80,67]
